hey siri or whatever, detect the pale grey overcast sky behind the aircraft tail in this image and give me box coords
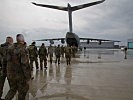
[0,0,133,44]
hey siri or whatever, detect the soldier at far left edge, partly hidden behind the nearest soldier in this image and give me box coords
[0,37,13,100]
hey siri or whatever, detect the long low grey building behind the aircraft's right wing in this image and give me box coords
[81,41,119,49]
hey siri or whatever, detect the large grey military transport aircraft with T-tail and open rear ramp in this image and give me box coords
[32,0,117,47]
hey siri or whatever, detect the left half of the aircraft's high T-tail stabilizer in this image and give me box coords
[32,2,67,11]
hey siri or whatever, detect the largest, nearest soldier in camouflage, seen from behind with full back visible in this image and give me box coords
[5,34,31,100]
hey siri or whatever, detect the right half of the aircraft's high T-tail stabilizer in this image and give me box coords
[72,0,105,11]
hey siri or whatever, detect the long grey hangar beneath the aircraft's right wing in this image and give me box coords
[80,41,120,49]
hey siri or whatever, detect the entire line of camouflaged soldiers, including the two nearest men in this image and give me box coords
[0,34,76,100]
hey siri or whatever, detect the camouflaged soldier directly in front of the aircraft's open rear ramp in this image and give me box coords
[65,45,72,65]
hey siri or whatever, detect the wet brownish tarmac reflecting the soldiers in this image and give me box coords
[3,49,133,100]
